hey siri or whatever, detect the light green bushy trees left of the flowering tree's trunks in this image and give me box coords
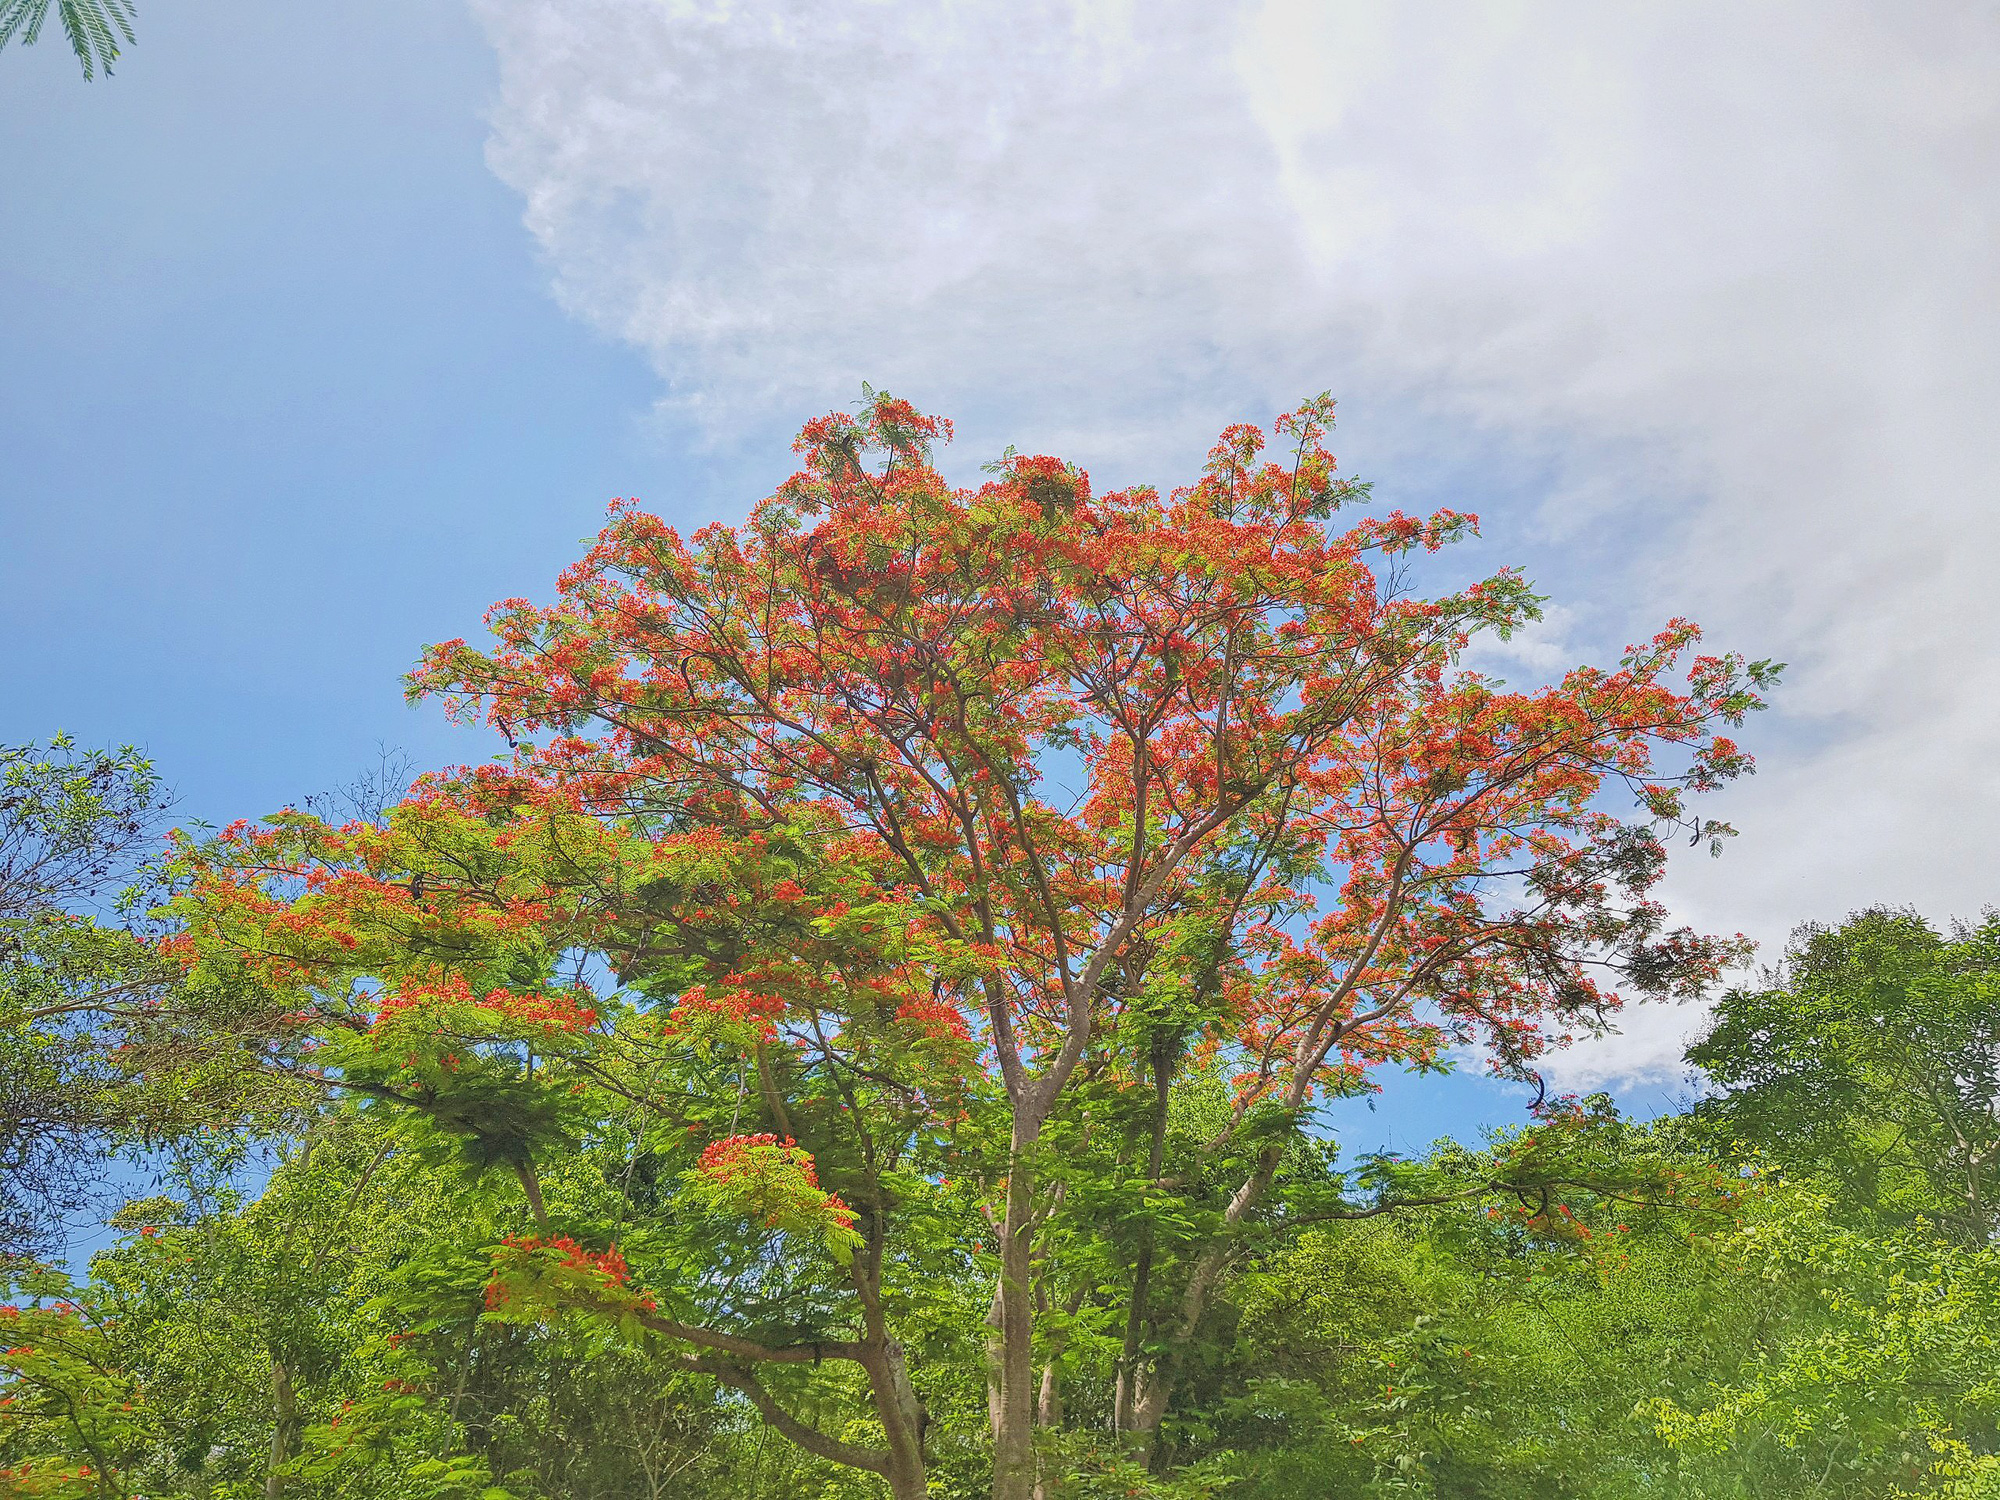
[0,1108,742,1500]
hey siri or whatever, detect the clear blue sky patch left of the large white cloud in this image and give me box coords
[0,2,674,836]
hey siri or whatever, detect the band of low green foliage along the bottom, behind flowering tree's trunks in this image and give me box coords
[11,1016,2000,1500]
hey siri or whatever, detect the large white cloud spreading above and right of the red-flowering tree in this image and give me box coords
[478,0,2000,1076]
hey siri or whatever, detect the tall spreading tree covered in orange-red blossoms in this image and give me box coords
[168,396,1770,1500]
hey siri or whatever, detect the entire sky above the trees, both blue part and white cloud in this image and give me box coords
[0,0,2000,1148]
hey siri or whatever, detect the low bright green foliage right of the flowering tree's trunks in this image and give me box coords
[1218,1186,2000,1500]
